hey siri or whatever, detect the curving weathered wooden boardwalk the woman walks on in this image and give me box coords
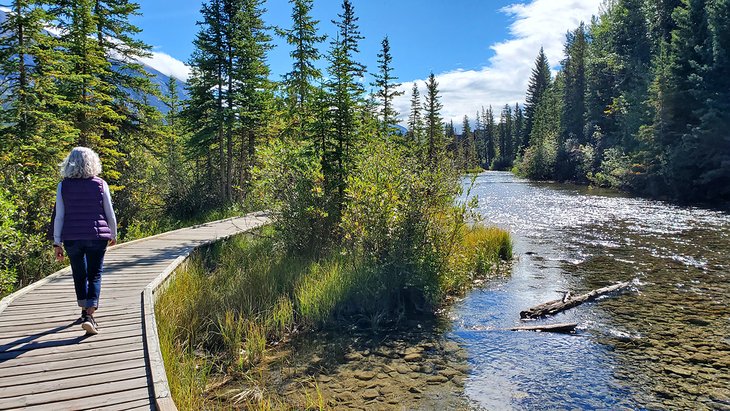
[0,214,269,410]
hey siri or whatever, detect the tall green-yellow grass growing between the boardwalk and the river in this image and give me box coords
[156,226,511,409]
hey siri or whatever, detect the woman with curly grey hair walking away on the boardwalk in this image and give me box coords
[53,147,117,335]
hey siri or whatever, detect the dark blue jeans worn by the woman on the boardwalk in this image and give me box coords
[63,240,108,308]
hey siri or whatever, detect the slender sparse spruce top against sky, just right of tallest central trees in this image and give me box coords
[372,36,403,134]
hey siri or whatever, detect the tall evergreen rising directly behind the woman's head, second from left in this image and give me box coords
[49,0,156,183]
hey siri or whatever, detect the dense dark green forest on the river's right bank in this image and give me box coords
[516,0,730,203]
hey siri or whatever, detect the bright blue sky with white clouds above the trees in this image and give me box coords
[129,0,602,120]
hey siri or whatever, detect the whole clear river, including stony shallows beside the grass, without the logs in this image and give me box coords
[253,172,730,410]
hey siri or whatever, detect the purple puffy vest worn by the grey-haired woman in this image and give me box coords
[61,177,112,241]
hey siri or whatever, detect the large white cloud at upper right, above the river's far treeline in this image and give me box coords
[395,0,603,125]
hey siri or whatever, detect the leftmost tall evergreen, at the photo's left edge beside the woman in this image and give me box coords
[0,0,74,235]
